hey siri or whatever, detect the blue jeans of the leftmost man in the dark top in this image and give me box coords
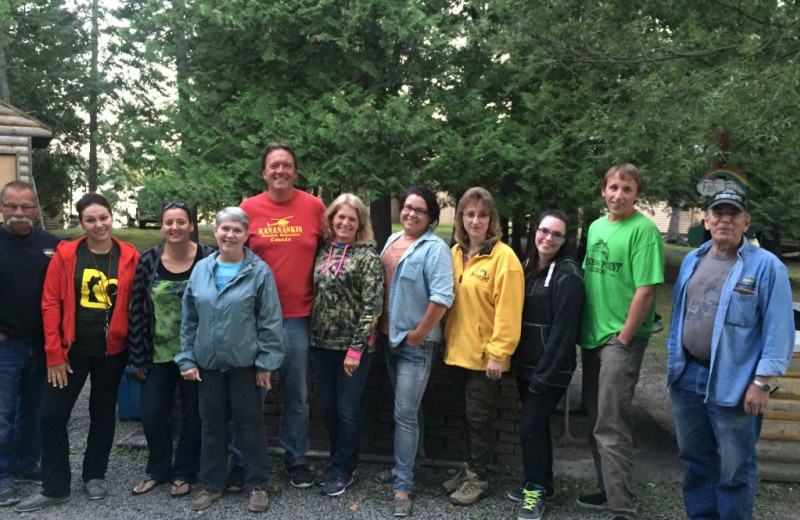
[0,337,47,482]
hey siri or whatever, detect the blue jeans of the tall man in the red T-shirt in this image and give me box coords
[278,316,311,468]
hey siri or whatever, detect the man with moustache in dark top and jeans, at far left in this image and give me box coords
[0,181,58,506]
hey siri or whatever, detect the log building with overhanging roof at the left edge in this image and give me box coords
[0,101,53,224]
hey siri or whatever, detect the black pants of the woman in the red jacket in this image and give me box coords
[39,352,128,497]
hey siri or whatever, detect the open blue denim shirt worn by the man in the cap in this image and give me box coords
[667,240,794,406]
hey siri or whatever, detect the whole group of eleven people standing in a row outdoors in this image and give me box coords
[0,144,791,520]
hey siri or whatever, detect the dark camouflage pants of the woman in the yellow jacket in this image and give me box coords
[451,367,500,480]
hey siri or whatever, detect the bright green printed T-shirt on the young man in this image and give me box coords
[580,211,664,348]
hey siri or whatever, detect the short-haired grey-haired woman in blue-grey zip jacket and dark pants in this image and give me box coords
[175,207,284,512]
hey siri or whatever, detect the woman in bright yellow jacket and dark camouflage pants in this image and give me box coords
[444,188,525,505]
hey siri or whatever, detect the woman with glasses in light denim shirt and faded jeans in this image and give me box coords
[378,186,454,516]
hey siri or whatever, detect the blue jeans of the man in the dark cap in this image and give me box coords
[669,362,763,520]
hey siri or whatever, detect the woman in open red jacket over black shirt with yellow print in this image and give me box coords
[16,193,139,512]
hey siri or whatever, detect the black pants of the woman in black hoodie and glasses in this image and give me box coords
[517,377,567,495]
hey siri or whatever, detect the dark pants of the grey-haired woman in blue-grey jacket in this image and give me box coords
[200,366,269,493]
